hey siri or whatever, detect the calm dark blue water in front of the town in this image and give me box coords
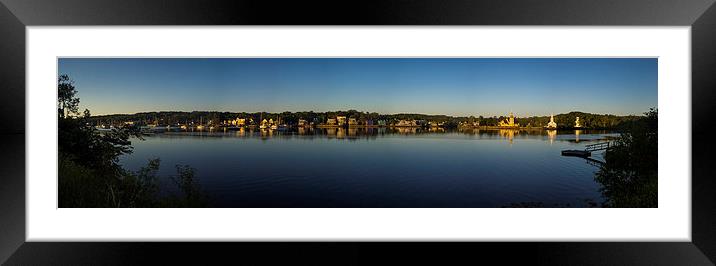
[121,128,615,207]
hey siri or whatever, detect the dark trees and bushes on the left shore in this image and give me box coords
[58,75,207,208]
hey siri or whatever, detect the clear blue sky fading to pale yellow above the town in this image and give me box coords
[59,58,657,116]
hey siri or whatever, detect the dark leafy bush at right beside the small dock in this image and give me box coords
[595,109,658,208]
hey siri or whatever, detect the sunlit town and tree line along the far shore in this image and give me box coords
[86,110,640,132]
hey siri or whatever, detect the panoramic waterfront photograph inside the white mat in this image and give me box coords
[57,57,658,208]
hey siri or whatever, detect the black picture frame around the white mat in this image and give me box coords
[0,0,716,265]
